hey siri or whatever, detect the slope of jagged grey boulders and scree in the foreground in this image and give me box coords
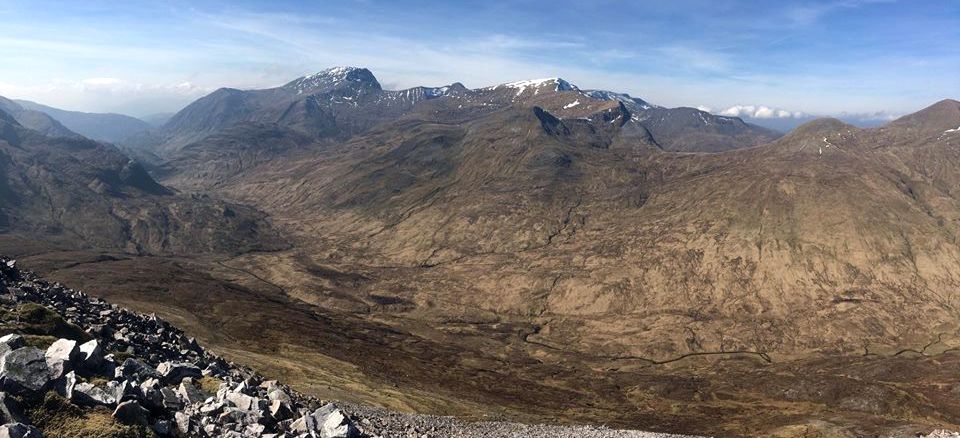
[0,257,704,438]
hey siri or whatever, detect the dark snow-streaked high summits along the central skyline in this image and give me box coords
[159,67,777,153]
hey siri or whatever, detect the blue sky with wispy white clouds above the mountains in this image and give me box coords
[0,0,960,119]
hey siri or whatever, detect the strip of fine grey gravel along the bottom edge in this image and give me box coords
[341,405,696,438]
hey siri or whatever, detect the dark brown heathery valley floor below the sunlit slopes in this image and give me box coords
[0,239,960,437]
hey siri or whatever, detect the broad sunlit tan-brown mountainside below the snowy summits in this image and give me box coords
[161,99,960,360]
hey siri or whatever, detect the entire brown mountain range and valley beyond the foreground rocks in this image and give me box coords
[0,67,960,436]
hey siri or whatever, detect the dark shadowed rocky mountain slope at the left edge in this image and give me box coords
[0,106,280,253]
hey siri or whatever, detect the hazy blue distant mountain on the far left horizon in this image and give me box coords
[16,100,152,143]
